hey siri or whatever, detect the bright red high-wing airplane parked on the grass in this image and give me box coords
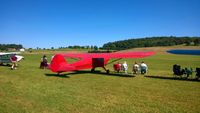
[48,52,155,74]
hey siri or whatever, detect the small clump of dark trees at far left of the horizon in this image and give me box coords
[0,44,23,51]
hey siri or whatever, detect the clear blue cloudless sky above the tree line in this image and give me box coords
[0,0,200,48]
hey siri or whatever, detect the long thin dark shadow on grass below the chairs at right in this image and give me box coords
[145,76,200,82]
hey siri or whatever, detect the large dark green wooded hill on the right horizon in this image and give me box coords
[102,36,200,50]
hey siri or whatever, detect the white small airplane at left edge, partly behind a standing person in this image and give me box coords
[0,52,24,65]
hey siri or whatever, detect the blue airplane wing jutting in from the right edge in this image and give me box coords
[167,49,200,55]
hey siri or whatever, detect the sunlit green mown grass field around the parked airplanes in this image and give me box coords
[0,48,200,113]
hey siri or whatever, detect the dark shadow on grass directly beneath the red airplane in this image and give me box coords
[45,71,135,78]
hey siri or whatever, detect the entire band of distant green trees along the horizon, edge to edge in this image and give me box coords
[0,36,200,51]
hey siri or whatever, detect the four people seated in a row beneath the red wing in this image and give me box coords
[113,61,148,74]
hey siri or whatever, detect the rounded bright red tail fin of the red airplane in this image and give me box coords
[49,54,67,72]
